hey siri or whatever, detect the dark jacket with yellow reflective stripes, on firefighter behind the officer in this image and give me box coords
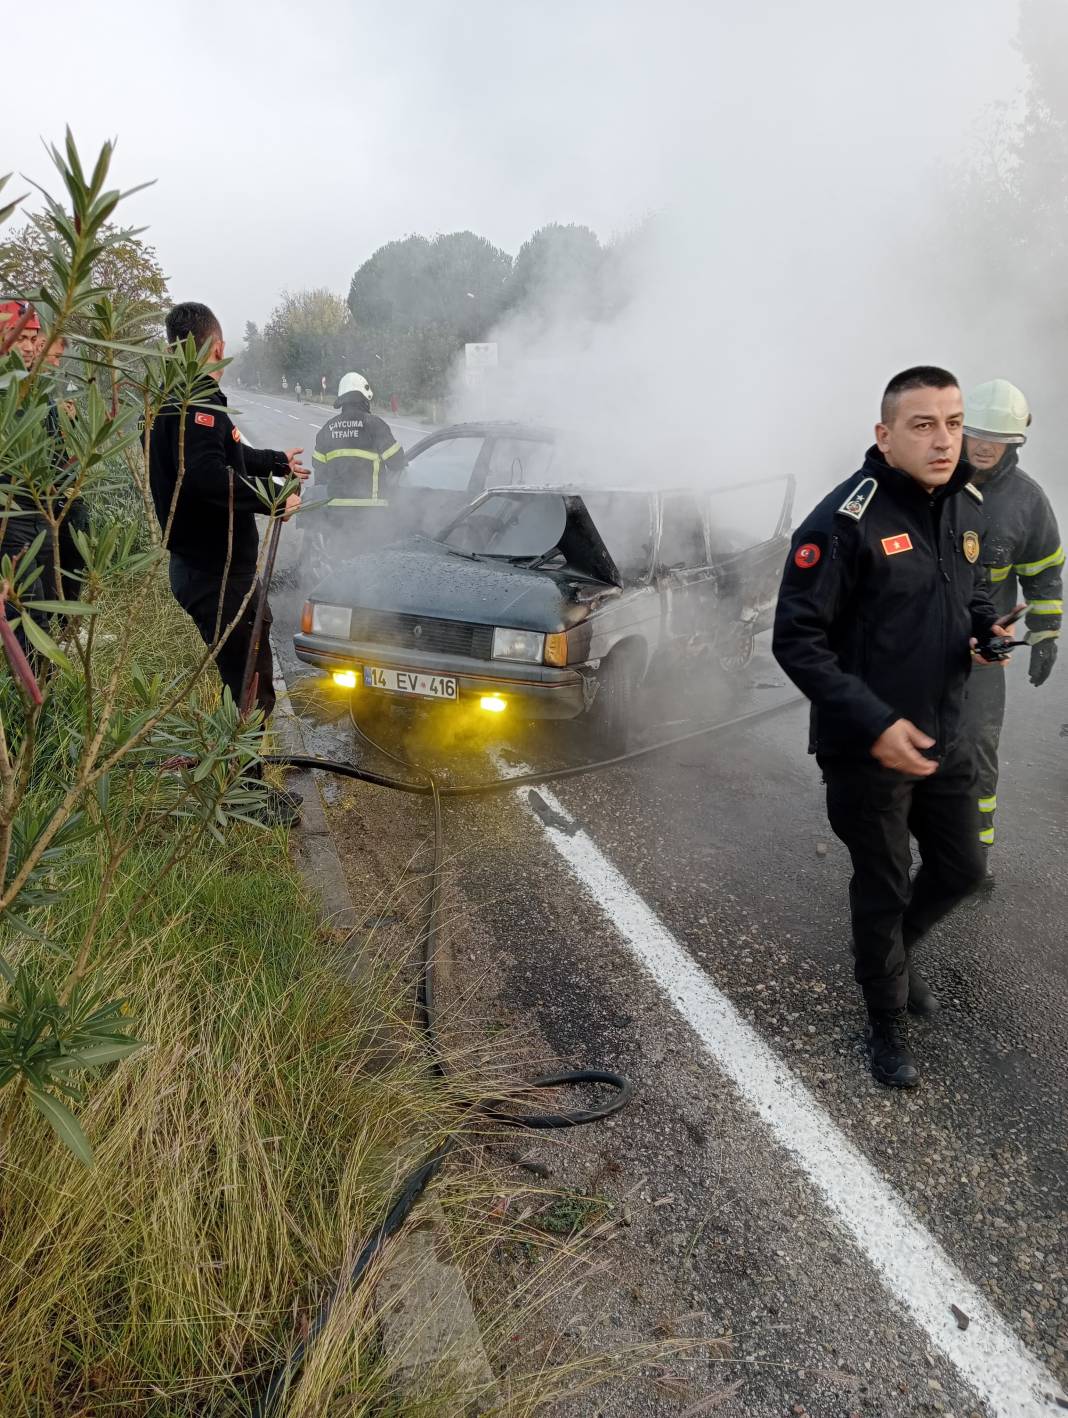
[972,448,1064,641]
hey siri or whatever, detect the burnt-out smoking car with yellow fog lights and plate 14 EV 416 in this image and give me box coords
[294,476,793,750]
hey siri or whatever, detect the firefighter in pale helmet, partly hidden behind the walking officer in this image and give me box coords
[964,379,1064,886]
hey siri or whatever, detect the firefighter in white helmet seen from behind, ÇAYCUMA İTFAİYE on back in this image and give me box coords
[312,372,408,575]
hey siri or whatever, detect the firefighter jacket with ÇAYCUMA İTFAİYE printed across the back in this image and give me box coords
[312,394,408,508]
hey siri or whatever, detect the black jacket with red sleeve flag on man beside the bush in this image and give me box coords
[149,389,289,577]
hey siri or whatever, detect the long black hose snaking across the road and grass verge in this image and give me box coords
[255,696,804,1418]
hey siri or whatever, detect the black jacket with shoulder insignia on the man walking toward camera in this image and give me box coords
[773,448,997,757]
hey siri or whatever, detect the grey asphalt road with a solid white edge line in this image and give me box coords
[237,400,1068,1418]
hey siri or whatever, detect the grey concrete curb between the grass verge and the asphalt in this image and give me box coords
[271,651,501,1414]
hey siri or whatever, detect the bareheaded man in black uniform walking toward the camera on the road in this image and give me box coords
[773,366,1011,1088]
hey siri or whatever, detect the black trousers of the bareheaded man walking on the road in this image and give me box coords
[820,742,986,1010]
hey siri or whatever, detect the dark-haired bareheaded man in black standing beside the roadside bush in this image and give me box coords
[149,302,308,824]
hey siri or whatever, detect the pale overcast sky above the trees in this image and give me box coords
[0,0,1020,340]
